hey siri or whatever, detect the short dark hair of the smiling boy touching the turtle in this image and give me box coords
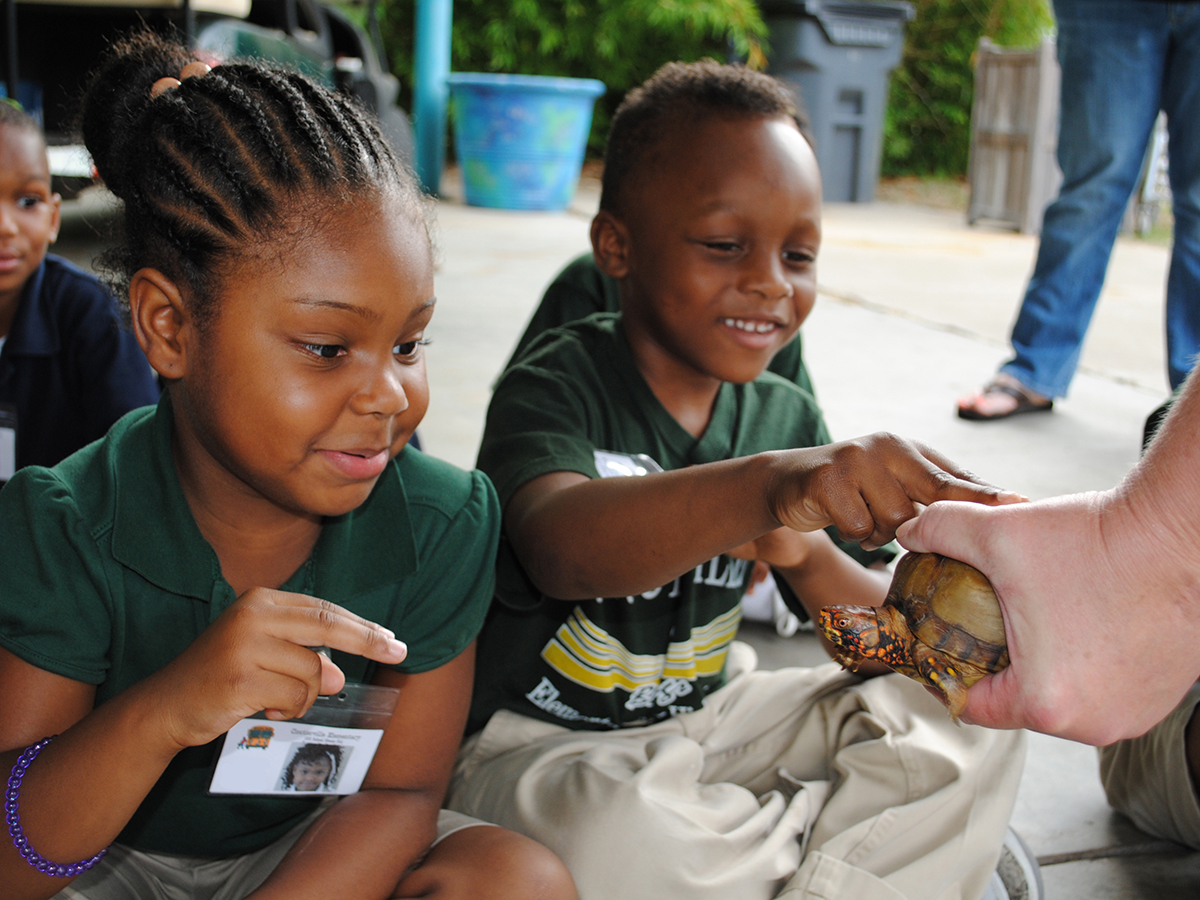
[600,59,812,212]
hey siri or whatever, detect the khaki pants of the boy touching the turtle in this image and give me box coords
[448,643,1025,900]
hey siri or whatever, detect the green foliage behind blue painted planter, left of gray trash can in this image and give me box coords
[380,0,767,152]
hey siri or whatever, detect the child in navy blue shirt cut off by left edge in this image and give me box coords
[0,102,158,485]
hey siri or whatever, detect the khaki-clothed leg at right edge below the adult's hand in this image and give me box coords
[1100,684,1200,850]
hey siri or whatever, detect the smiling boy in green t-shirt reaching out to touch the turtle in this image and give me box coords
[450,61,1024,900]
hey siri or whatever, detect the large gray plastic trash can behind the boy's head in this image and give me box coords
[762,0,913,203]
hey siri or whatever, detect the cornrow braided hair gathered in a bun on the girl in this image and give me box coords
[82,30,424,322]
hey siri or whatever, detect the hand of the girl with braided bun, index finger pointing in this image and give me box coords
[144,588,407,749]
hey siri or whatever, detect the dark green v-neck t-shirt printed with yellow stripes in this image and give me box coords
[468,313,864,731]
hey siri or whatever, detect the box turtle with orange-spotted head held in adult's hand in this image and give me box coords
[818,553,1008,719]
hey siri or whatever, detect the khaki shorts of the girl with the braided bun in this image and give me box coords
[50,798,488,900]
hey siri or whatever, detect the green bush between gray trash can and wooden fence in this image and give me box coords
[883,0,1054,176]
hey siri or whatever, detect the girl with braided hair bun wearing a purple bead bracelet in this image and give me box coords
[0,32,575,900]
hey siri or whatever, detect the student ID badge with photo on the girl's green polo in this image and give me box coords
[209,684,400,797]
